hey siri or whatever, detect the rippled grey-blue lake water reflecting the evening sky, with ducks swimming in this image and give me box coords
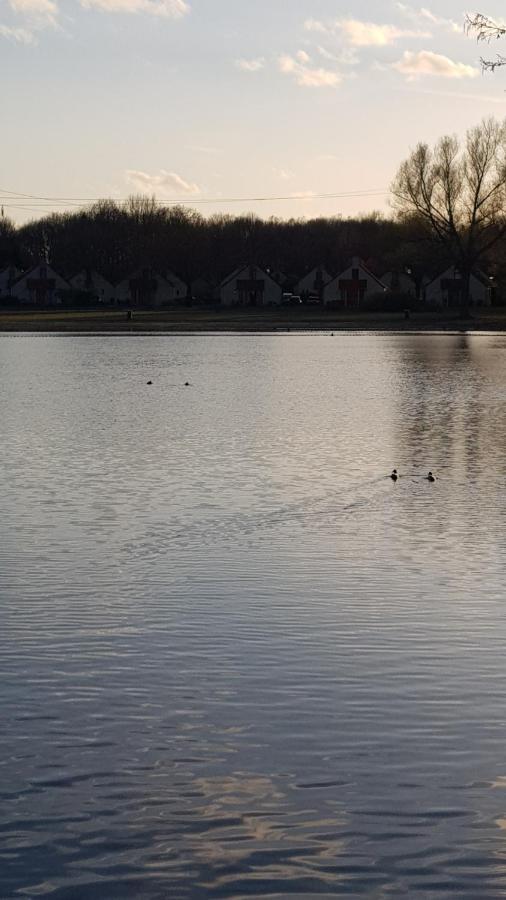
[0,334,506,900]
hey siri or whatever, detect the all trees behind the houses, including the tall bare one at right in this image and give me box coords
[0,119,506,305]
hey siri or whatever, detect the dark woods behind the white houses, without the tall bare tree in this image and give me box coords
[0,197,444,284]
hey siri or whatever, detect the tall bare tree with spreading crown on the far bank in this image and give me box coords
[391,118,506,313]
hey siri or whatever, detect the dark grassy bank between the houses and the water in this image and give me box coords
[0,307,506,334]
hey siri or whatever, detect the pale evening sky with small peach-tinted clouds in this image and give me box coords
[0,0,506,222]
